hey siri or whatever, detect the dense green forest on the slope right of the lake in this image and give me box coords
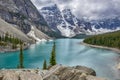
[84,31,120,49]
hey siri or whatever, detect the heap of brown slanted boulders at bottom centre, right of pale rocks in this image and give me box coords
[43,65,97,80]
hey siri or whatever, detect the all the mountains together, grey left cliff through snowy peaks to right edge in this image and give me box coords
[0,0,120,39]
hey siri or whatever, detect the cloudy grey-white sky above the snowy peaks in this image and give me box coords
[31,0,120,19]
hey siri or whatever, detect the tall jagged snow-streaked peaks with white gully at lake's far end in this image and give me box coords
[40,4,85,37]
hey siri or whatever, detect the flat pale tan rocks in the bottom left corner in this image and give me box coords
[0,70,43,80]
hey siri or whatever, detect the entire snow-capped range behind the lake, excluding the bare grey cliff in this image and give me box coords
[40,4,120,37]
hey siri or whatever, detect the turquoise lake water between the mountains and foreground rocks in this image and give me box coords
[0,39,120,80]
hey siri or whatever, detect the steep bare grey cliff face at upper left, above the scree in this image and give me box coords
[0,0,48,33]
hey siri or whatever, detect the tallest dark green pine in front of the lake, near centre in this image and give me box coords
[50,42,57,66]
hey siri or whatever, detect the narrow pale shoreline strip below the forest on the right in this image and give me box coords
[80,42,120,53]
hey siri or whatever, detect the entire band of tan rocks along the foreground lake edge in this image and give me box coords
[0,65,107,80]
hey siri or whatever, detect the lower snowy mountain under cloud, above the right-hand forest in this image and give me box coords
[90,16,120,34]
